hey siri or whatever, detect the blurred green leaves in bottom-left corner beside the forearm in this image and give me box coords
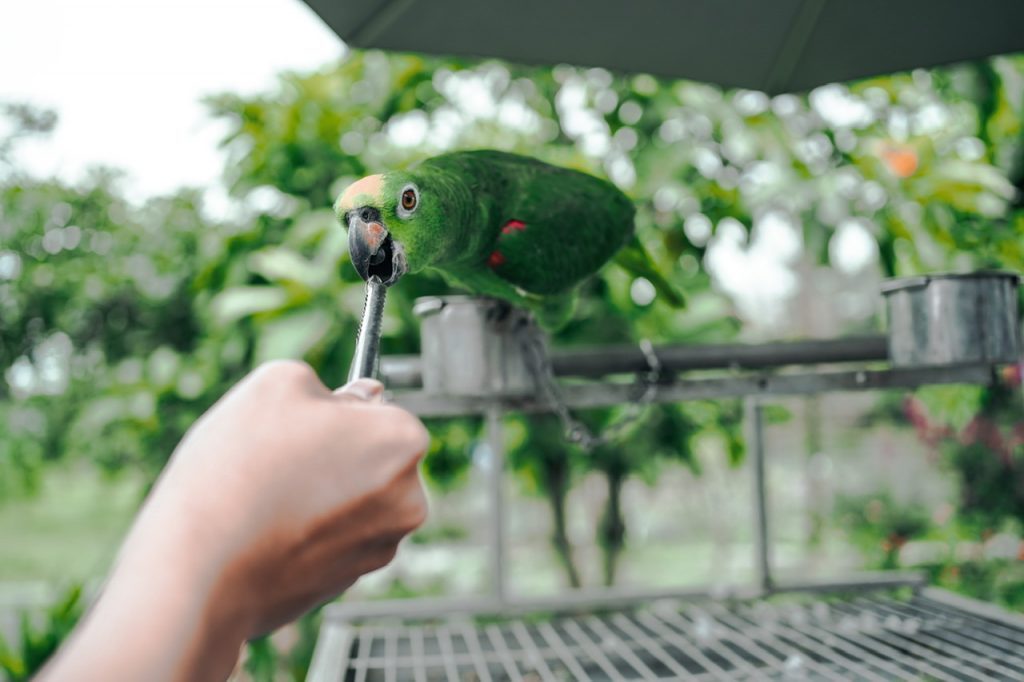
[0,585,84,682]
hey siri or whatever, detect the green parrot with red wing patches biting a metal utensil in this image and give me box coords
[335,150,683,329]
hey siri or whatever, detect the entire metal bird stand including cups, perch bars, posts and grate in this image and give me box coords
[310,275,1024,682]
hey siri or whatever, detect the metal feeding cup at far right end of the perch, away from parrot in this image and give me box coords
[882,272,1021,367]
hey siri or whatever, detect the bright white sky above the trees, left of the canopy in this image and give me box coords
[0,0,344,199]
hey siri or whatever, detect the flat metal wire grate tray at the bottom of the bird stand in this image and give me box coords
[325,593,1024,682]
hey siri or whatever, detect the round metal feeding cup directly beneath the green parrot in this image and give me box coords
[413,296,544,396]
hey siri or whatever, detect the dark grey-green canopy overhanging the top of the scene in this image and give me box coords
[305,0,1024,93]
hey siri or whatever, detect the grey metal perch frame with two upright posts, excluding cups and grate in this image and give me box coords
[326,325,994,621]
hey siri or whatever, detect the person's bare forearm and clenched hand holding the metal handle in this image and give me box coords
[42,361,428,680]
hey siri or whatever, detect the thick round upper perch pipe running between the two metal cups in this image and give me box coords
[381,335,889,388]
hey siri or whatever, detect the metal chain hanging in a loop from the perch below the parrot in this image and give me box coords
[517,319,663,453]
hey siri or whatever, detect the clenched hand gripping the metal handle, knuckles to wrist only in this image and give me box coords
[152,361,429,637]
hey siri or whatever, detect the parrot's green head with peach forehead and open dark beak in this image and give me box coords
[334,172,452,286]
